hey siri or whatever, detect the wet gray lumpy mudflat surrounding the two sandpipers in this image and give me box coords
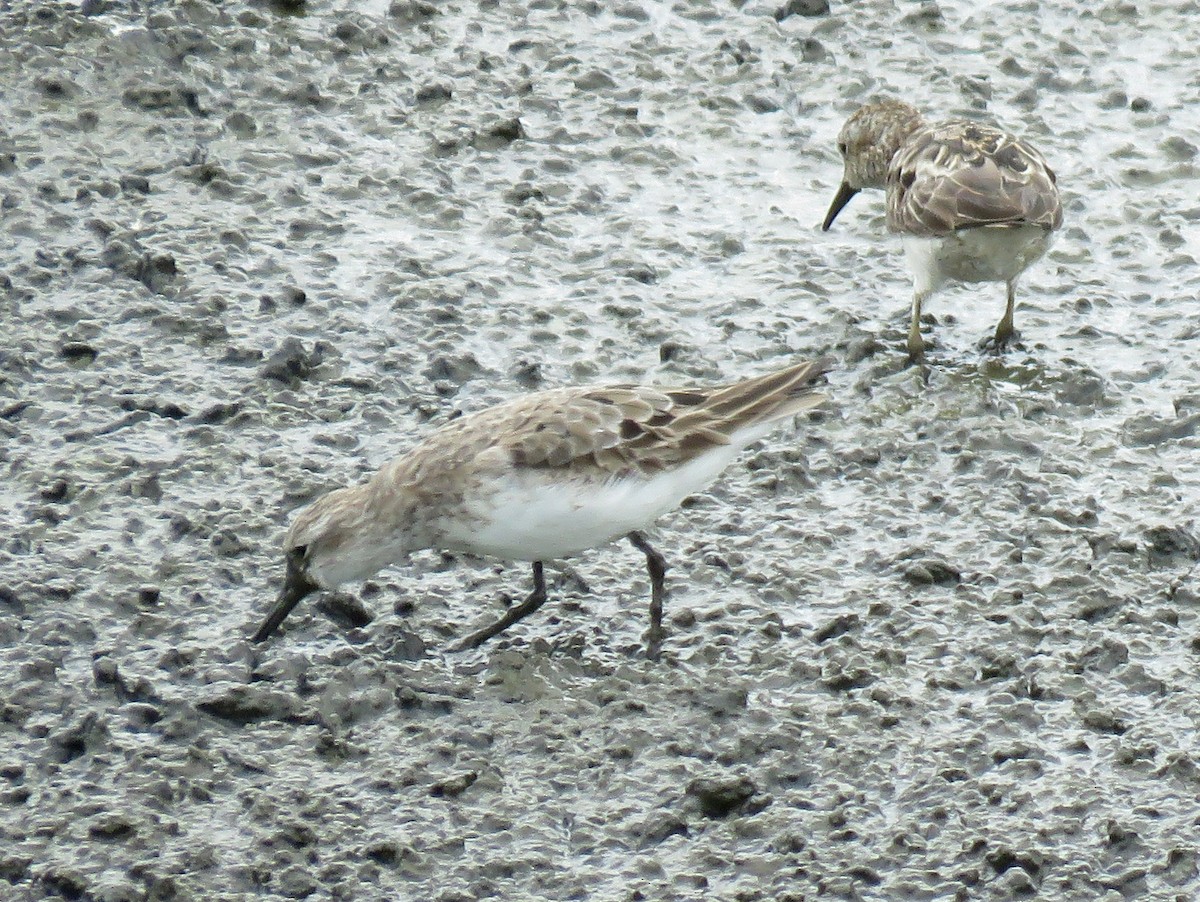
[0,0,1200,902]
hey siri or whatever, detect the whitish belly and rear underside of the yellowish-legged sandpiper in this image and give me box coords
[904,226,1052,293]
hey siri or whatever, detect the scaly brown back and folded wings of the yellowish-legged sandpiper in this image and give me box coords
[887,121,1062,235]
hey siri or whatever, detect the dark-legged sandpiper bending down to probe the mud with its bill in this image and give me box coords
[253,359,830,657]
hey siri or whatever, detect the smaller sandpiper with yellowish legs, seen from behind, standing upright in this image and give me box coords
[822,101,1062,360]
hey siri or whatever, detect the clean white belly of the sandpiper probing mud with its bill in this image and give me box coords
[439,445,742,560]
